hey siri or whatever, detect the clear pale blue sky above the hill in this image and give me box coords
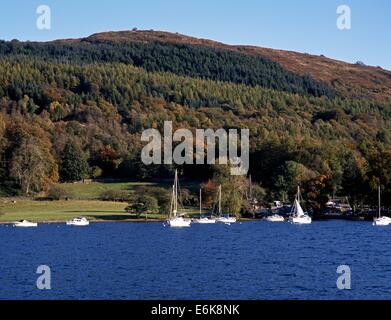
[0,0,391,70]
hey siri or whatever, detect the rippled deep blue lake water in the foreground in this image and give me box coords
[0,221,391,299]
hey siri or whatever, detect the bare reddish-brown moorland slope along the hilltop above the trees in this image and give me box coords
[83,31,391,100]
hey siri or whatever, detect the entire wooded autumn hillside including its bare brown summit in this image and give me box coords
[0,31,391,209]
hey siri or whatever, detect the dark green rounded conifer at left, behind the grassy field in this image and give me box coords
[60,142,89,182]
